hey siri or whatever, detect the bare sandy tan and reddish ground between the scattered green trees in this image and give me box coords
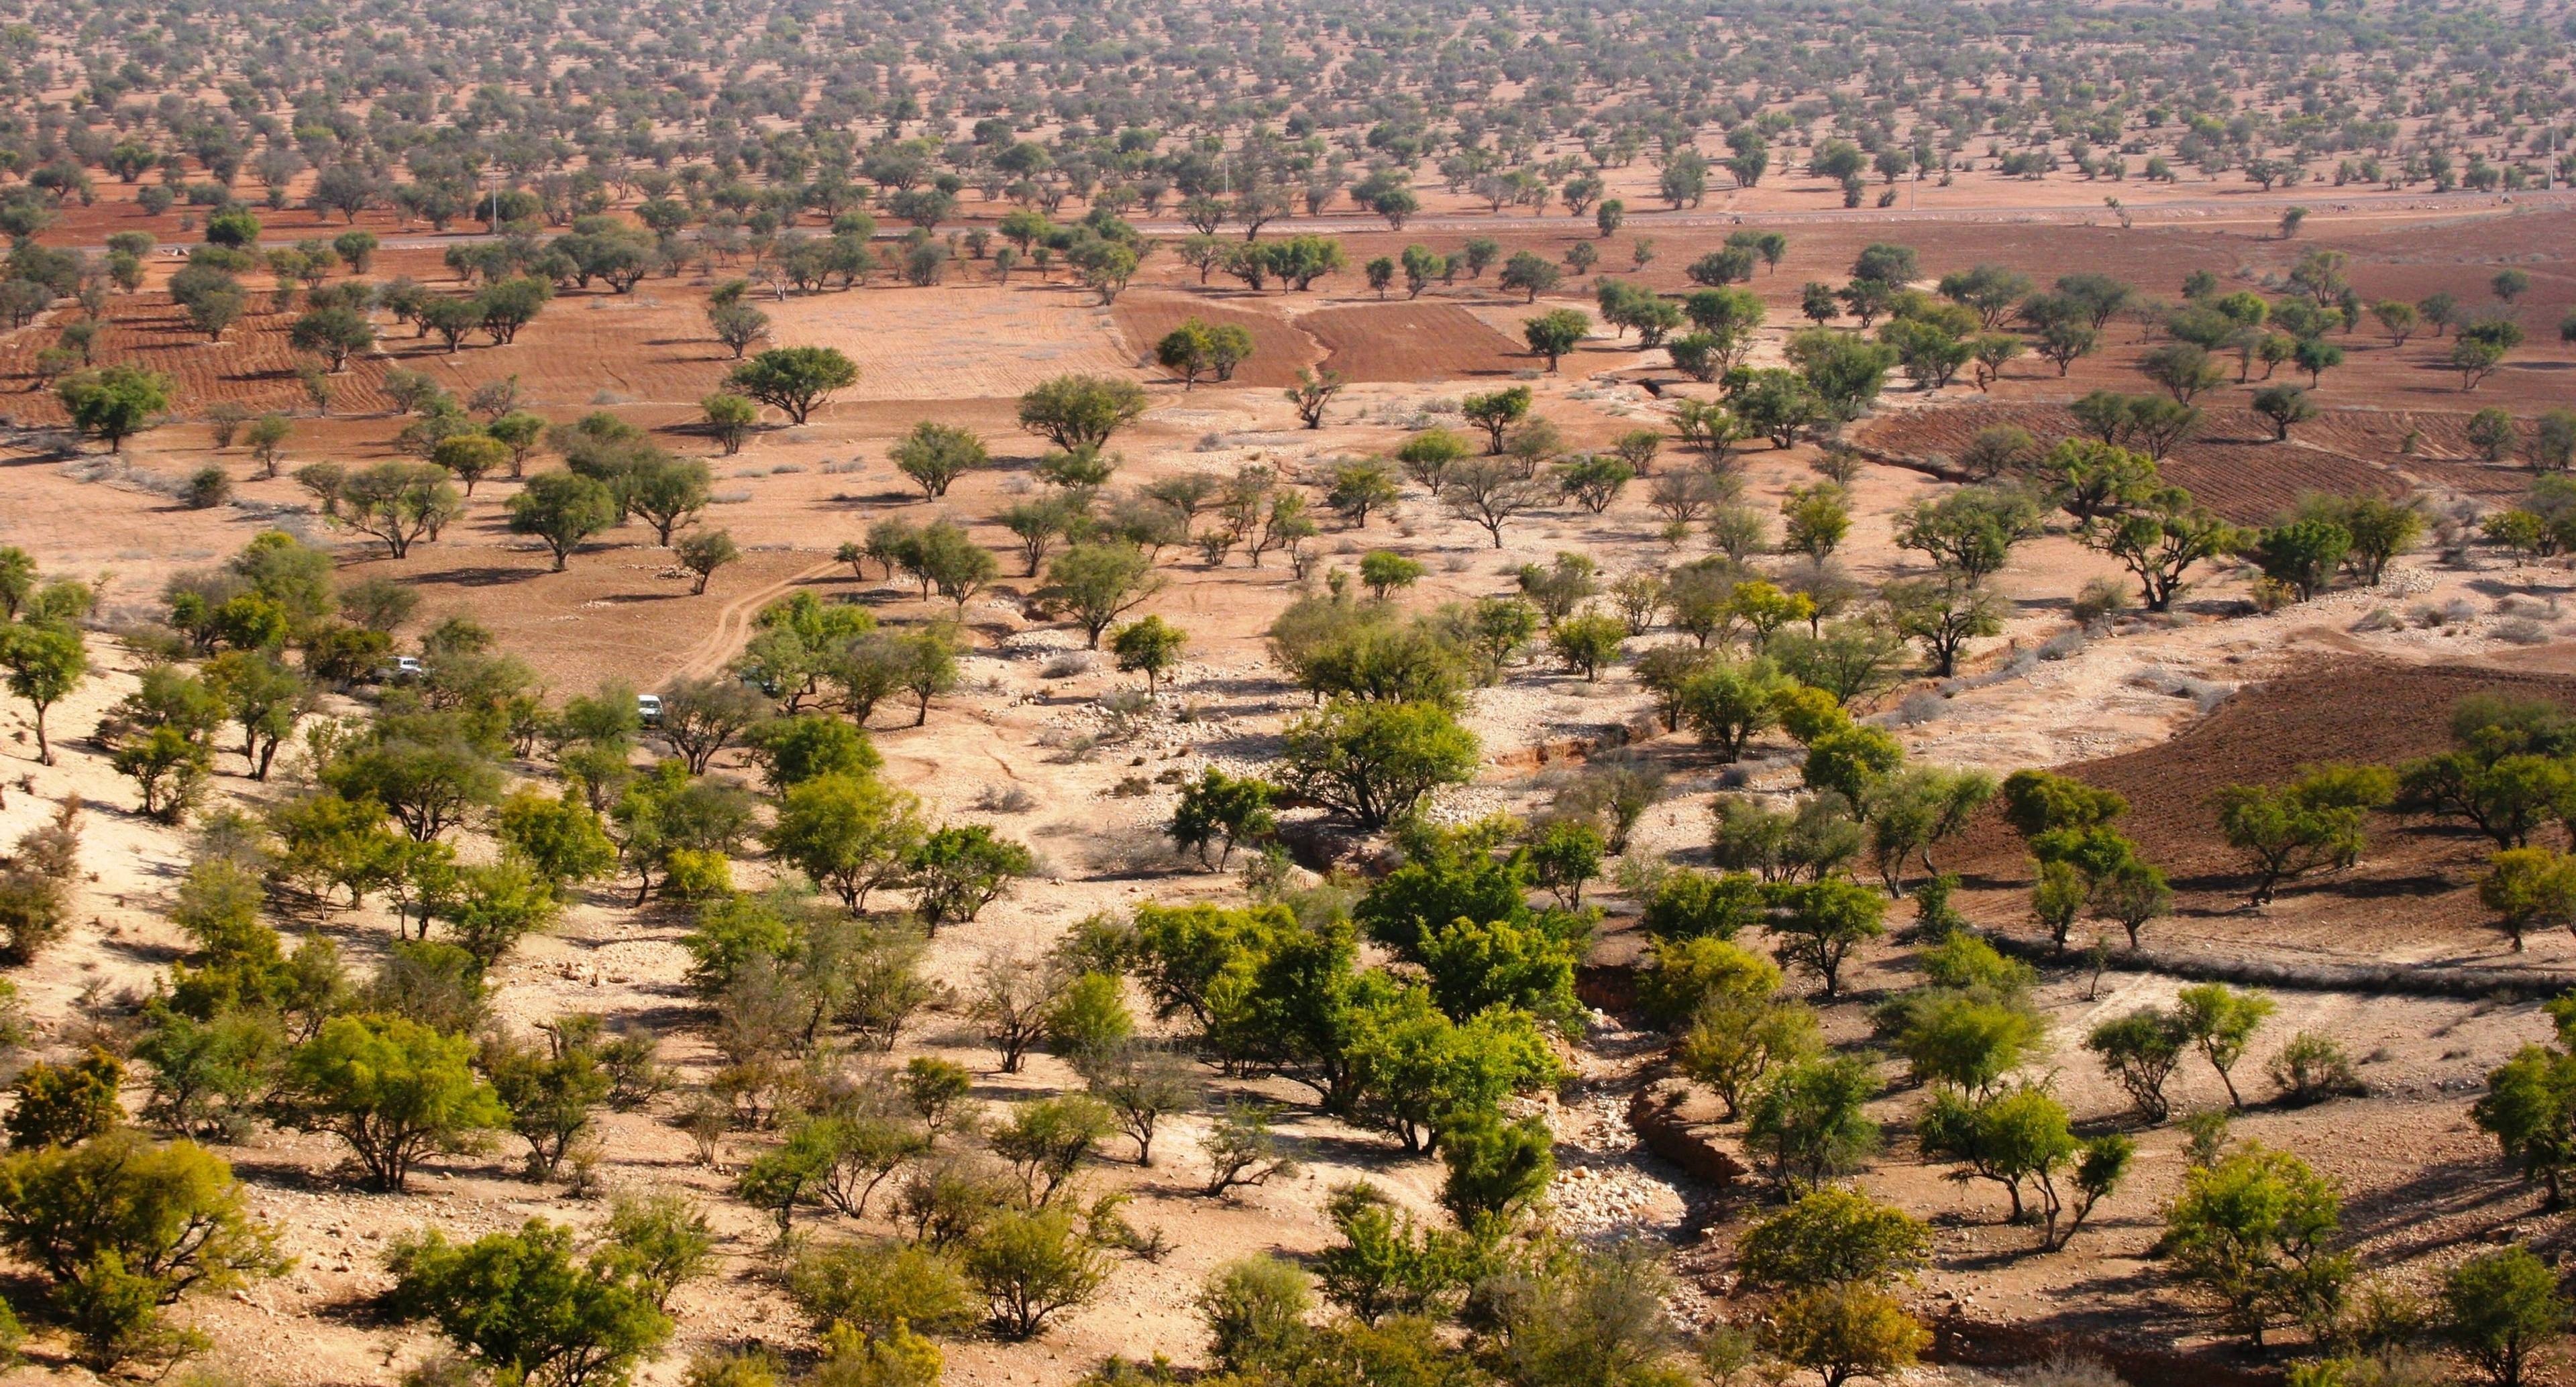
[0,203,2576,1387]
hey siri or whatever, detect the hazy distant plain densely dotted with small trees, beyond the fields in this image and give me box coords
[0,5,2566,283]
